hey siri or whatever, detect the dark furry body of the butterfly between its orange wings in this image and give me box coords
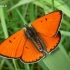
[25,25,45,52]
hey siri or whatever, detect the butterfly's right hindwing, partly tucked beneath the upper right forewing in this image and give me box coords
[39,32,61,53]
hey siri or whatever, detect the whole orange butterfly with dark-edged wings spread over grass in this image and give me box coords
[0,10,62,63]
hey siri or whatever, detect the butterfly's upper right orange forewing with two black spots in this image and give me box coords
[32,10,62,37]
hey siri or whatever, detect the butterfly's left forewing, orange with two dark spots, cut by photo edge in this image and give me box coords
[0,30,26,58]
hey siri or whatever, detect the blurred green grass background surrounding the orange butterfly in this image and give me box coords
[0,0,70,70]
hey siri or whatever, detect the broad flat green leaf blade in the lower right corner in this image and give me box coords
[43,49,70,70]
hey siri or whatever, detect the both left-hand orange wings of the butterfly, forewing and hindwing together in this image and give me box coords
[0,30,44,63]
